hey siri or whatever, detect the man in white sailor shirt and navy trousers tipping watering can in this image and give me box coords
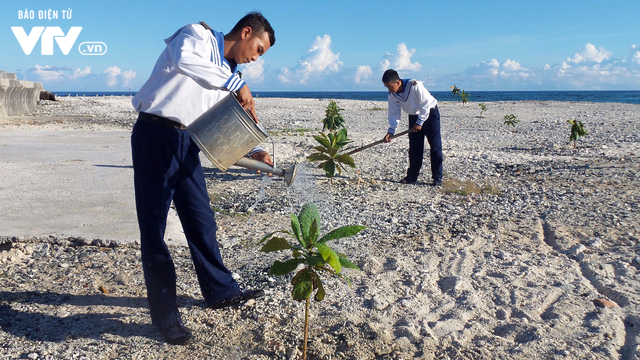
[131,12,275,344]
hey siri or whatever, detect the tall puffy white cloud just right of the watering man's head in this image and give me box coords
[278,34,343,84]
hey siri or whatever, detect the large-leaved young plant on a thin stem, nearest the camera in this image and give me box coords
[260,202,365,359]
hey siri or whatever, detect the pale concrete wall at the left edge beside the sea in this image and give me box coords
[0,71,42,117]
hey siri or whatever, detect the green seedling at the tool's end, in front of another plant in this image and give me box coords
[307,128,356,184]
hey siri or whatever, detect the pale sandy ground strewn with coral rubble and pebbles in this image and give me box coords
[0,97,640,360]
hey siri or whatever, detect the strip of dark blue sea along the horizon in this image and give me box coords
[54,90,640,104]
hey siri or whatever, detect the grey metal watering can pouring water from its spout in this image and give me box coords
[187,93,296,186]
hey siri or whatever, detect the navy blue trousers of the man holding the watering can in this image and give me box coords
[131,120,240,326]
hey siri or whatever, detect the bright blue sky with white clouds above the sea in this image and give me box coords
[5,0,640,91]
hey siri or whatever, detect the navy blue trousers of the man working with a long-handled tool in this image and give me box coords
[407,106,442,181]
